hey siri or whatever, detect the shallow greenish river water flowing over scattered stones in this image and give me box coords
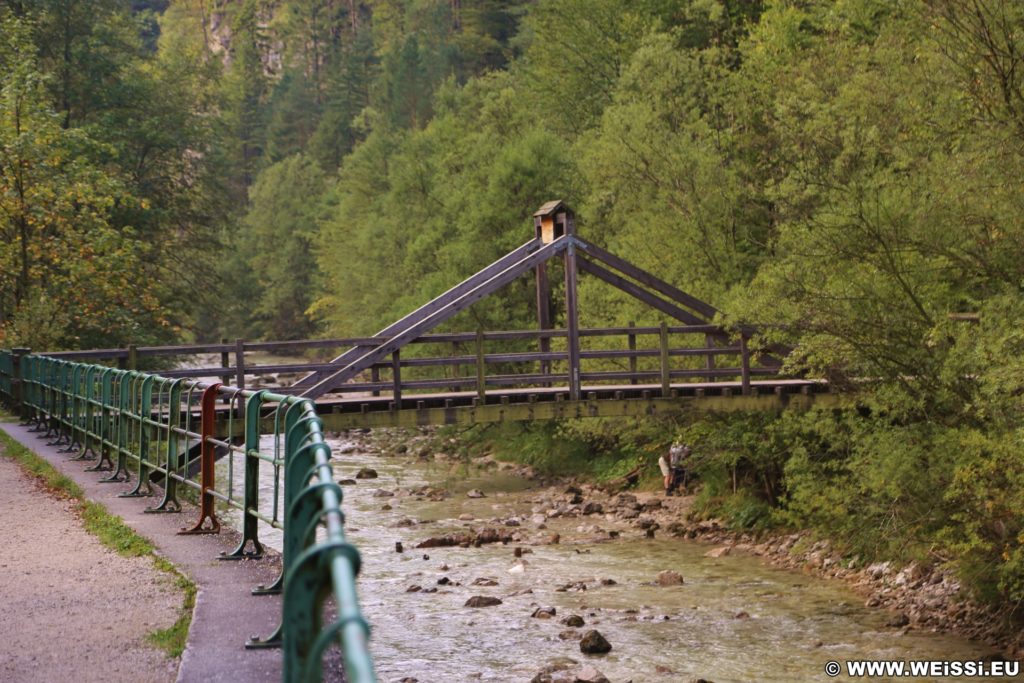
[218,440,1007,683]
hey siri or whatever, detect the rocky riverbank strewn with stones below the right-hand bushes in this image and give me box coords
[348,431,1024,659]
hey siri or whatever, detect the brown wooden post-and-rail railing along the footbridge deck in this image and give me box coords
[34,325,779,402]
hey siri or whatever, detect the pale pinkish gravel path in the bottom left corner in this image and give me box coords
[0,450,182,683]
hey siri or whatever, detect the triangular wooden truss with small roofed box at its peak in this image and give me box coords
[291,201,757,400]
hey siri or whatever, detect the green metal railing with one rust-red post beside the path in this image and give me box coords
[0,349,376,683]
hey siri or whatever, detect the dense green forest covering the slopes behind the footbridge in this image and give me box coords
[0,0,1024,618]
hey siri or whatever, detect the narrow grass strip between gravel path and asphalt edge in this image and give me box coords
[0,423,197,658]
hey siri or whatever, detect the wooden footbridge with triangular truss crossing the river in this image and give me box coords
[41,201,830,430]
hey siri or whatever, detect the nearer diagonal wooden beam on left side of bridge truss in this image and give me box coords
[299,236,572,398]
